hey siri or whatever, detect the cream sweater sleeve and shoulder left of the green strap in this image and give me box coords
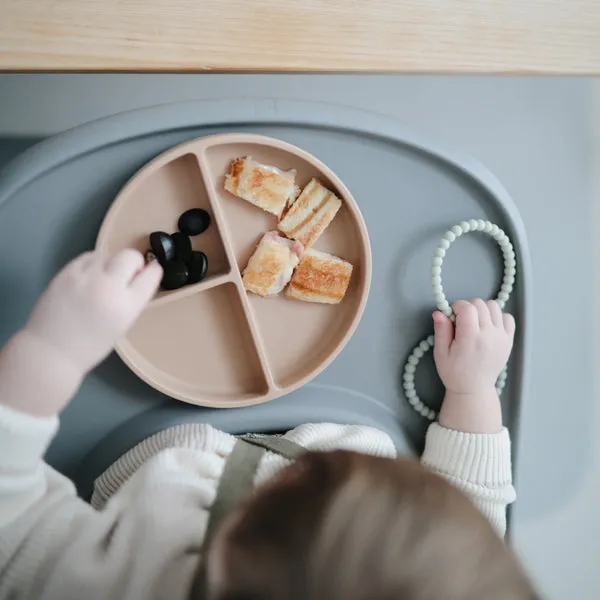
[0,406,211,600]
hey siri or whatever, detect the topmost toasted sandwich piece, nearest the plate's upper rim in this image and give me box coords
[225,156,300,217]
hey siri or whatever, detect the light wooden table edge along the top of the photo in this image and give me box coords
[0,0,600,75]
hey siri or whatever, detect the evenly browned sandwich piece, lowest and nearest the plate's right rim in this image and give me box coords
[286,248,352,304]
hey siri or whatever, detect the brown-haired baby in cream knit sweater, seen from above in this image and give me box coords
[0,250,537,600]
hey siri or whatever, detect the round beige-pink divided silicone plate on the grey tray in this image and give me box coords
[97,134,371,408]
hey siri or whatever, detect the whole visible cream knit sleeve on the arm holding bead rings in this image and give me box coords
[421,423,515,536]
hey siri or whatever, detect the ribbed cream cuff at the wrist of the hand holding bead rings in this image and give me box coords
[421,423,512,486]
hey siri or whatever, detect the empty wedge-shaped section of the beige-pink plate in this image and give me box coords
[118,283,269,407]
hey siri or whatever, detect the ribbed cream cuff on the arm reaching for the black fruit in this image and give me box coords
[0,404,58,472]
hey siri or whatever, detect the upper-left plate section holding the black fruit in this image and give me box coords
[98,153,231,303]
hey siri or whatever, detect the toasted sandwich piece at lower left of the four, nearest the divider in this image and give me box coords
[242,231,304,296]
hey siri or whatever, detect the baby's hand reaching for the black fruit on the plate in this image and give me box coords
[25,250,162,375]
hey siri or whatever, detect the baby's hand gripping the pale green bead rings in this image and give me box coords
[433,300,515,395]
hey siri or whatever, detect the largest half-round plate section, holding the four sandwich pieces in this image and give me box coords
[199,140,370,389]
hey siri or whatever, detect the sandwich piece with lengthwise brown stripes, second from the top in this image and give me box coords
[279,179,342,248]
